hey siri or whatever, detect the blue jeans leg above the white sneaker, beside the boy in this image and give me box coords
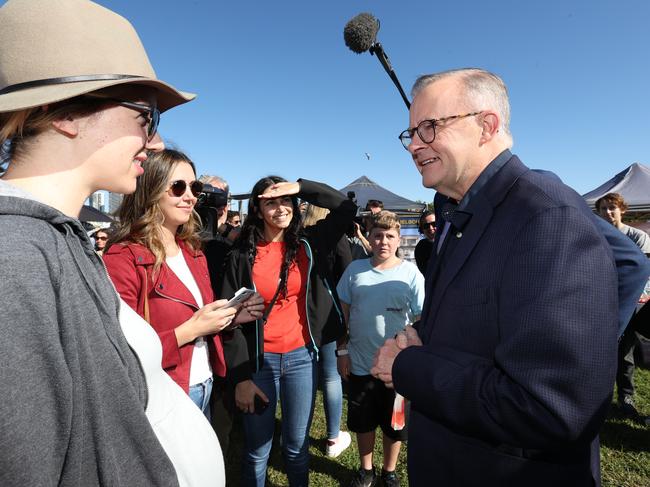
[318,341,343,440]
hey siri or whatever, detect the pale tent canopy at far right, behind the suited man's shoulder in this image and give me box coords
[582,162,650,212]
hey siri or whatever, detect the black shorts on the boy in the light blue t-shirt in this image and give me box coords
[348,374,409,441]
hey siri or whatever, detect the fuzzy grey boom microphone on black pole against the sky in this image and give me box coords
[343,12,411,108]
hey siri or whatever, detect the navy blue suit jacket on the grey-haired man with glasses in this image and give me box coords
[393,156,618,487]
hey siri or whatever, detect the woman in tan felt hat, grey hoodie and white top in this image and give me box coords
[0,0,224,486]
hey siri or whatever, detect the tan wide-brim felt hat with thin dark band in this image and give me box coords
[0,0,196,112]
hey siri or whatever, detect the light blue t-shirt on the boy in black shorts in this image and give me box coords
[336,259,424,375]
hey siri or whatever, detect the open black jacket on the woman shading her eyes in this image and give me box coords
[218,179,357,384]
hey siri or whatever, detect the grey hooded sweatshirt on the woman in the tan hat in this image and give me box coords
[0,180,178,487]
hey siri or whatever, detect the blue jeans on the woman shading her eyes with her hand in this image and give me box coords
[241,347,316,487]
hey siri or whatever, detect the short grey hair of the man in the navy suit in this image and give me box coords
[411,68,512,146]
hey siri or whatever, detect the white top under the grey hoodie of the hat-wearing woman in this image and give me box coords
[120,298,226,487]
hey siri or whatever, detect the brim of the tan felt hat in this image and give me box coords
[0,77,196,113]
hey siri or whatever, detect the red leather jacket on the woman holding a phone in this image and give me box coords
[103,241,226,392]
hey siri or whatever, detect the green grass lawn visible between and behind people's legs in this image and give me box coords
[226,369,650,487]
